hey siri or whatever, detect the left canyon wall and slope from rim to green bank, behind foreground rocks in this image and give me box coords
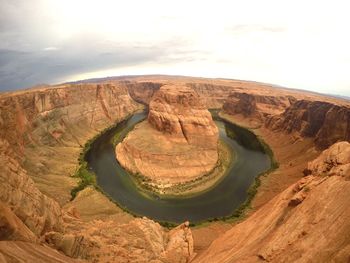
[0,84,139,204]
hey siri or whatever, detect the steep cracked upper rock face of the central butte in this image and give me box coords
[148,85,218,149]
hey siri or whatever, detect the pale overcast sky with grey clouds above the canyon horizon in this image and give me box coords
[0,0,350,96]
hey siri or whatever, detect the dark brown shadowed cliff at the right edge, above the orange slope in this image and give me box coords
[266,100,350,149]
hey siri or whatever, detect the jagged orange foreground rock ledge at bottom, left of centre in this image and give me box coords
[45,218,193,263]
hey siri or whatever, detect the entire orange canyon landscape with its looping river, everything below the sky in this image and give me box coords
[0,75,350,263]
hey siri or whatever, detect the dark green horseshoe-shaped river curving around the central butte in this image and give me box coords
[85,112,271,223]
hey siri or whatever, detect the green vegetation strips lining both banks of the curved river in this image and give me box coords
[71,109,278,228]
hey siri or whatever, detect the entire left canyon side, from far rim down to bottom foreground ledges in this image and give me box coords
[0,84,193,262]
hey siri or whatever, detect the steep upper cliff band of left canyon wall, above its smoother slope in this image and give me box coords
[0,84,137,154]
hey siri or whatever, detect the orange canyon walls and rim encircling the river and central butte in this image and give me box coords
[0,76,350,263]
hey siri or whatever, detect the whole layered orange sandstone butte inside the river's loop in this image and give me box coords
[116,85,218,186]
